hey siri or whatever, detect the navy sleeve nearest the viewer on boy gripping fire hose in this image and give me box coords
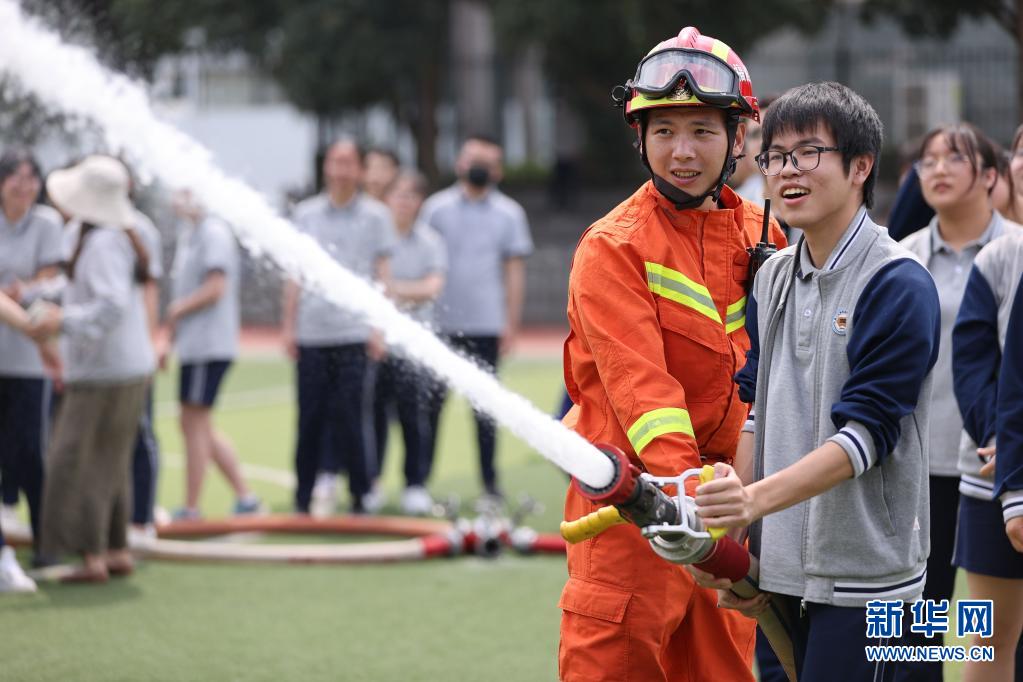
[831,259,941,462]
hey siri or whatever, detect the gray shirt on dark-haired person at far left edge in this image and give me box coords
[0,204,63,378]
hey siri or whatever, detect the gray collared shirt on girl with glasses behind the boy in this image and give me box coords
[899,211,1019,476]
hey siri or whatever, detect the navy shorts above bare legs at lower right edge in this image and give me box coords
[952,495,1023,580]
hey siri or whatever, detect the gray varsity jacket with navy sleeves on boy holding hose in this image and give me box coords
[736,208,940,606]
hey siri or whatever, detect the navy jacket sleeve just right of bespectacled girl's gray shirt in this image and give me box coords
[952,265,1002,447]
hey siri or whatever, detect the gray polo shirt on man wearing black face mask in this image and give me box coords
[420,185,533,336]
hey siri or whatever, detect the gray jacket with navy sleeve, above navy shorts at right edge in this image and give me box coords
[952,230,1023,511]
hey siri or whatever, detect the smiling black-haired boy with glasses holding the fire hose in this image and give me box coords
[690,83,940,682]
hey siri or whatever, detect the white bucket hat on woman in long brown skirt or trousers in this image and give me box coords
[46,155,135,228]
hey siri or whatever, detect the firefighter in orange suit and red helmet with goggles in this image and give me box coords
[559,27,785,682]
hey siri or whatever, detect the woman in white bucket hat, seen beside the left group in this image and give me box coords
[31,155,155,582]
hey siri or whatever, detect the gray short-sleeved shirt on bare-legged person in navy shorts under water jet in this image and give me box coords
[172,216,240,363]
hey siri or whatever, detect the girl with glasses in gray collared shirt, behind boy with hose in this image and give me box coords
[898,123,1020,680]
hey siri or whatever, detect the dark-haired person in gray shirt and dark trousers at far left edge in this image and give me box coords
[0,149,62,551]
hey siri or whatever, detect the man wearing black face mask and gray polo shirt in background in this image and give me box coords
[421,135,533,503]
